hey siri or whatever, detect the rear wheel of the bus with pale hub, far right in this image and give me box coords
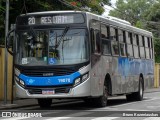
[126,77,144,101]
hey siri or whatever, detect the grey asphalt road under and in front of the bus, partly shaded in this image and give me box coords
[2,92,160,120]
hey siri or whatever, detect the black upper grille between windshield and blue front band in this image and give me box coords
[21,68,76,77]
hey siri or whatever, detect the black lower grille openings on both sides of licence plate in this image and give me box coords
[28,88,70,94]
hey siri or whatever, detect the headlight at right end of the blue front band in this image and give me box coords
[73,72,89,87]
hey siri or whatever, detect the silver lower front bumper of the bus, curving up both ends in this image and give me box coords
[15,78,91,98]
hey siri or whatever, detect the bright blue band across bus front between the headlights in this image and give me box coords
[19,72,81,86]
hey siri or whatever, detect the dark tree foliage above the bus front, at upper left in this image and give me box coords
[0,0,110,44]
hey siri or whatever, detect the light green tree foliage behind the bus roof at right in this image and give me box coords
[109,0,160,62]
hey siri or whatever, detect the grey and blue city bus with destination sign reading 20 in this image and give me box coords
[7,11,154,108]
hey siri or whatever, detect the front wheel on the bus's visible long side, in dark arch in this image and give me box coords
[94,85,108,107]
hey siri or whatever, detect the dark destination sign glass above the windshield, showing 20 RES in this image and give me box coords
[17,14,84,25]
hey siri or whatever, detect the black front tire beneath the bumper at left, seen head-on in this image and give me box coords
[38,98,52,108]
